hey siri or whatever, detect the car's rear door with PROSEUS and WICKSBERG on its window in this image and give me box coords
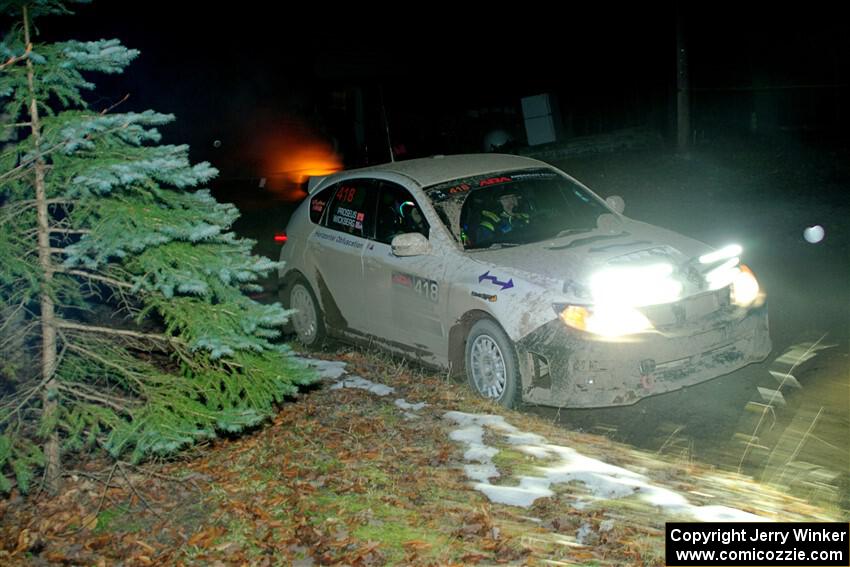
[308,179,376,332]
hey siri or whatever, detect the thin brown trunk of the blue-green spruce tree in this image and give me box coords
[23,6,62,494]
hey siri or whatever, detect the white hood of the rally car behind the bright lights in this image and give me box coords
[474,215,712,297]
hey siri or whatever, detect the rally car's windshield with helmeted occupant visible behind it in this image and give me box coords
[425,169,611,250]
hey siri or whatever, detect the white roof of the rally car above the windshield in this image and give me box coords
[314,154,549,191]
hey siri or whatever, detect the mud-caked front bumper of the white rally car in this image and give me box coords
[517,305,771,408]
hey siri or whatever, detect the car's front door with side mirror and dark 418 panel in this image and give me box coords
[363,181,447,354]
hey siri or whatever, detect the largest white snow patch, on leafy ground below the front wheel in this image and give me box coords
[444,411,765,520]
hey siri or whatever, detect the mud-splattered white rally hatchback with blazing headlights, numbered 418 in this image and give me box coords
[279,154,771,407]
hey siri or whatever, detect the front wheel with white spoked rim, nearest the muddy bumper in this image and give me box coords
[464,319,521,408]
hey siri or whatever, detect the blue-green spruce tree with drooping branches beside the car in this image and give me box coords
[0,0,312,492]
